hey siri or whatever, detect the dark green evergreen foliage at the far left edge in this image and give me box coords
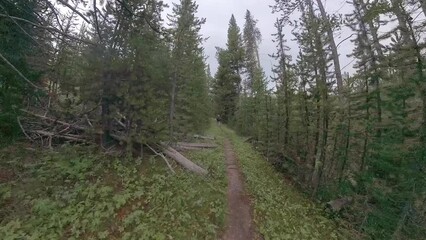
[0,0,40,143]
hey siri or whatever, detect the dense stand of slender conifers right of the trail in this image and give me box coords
[213,0,426,239]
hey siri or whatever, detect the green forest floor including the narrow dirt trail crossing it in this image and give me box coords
[0,124,359,240]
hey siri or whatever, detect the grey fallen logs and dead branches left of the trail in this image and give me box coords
[17,110,217,176]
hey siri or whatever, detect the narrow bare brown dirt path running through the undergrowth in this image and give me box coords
[222,139,255,240]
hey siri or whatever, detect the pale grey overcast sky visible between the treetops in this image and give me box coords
[164,0,353,81]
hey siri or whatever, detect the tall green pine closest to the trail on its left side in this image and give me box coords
[169,0,209,137]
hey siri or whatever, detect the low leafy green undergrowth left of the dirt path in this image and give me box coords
[0,125,226,240]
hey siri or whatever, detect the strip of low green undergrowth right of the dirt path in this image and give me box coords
[220,128,353,240]
